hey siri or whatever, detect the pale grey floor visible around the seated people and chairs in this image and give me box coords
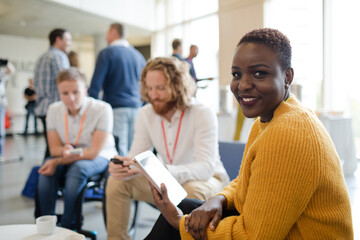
[0,123,360,240]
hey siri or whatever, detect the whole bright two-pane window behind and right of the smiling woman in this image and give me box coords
[264,0,360,156]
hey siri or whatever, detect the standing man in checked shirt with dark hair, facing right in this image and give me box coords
[34,28,72,158]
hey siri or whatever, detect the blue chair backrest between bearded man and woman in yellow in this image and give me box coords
[219,141,245,180]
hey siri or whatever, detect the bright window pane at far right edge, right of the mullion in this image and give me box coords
[324,0,360,156]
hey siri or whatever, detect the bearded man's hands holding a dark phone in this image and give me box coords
[109,156,140,180]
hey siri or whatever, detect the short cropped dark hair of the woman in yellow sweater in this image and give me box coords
[237,28,291,70]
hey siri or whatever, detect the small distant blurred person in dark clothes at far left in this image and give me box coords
[23,78,38,136]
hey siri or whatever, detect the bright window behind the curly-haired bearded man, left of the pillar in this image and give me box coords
[151,0,219,111]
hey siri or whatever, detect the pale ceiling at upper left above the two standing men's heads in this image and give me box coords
[0,0,151,41]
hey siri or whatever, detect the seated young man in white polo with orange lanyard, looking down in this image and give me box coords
[38,68,116,229]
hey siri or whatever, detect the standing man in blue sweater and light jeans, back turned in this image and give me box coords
[88,23,146,156]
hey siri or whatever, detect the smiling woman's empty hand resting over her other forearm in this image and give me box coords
[185,195,226,240]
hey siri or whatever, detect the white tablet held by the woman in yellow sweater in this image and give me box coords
[135,151,187,206]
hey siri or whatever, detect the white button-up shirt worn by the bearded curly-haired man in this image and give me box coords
[129,103,229,184]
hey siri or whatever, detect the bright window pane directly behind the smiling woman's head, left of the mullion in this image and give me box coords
[264,0,323,110]
